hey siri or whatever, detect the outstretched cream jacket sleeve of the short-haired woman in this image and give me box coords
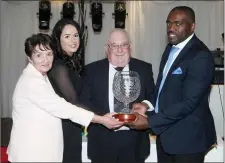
[26,78,94,126]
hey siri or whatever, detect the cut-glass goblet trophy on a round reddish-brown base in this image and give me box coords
[113,71,141,124]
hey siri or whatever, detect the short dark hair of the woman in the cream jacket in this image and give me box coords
[24,33,54,57]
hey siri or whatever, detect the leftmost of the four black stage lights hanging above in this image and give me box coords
[37,0,52,30]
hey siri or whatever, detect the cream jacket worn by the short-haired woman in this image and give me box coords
[7,64,94,162]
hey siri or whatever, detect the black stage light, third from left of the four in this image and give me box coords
[90,2,104,32]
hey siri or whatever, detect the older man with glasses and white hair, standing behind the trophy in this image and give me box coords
[81,29,155,163]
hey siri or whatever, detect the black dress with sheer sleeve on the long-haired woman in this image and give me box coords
[48,57,82,163]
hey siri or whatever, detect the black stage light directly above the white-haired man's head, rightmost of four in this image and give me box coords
[112,1,128,28]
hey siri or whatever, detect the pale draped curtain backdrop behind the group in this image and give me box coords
[0,1,224,117]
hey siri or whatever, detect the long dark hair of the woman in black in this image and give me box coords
[51,19,83,72]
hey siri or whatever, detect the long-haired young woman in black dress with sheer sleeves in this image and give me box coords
[48,19,85,163]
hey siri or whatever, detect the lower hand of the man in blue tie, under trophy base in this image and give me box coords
[127,112,149,130]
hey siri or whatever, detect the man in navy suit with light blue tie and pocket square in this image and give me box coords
[131,6,216,163]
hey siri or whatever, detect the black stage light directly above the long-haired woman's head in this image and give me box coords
[61,2,75,20]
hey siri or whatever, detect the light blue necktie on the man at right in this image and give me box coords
[155,46,179,113]
